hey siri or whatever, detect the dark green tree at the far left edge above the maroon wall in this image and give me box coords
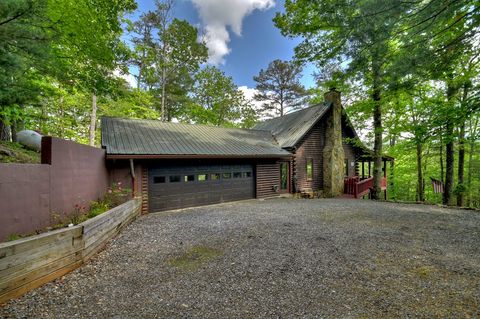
[0,0,50,140]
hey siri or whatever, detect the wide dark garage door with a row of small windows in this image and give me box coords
[148,165,255,212]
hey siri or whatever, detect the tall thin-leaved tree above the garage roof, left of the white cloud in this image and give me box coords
[129,0,208,121]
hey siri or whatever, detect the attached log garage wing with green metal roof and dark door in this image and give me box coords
[102,117,292,213]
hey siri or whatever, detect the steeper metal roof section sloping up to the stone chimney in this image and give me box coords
[254,102,331,148]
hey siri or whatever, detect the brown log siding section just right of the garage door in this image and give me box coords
[256,162,280,198]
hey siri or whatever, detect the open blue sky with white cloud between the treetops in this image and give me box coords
[129,0,314,88]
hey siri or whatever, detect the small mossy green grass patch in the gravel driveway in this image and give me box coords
[167,245,223,271]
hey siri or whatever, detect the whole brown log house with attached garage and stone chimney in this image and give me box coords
[102,89,392,212]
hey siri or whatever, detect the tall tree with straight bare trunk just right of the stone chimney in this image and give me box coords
[274,0,409,199]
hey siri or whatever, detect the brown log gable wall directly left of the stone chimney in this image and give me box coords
[293,121,325,192]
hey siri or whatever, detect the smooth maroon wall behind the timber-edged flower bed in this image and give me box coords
[0,136,109,241]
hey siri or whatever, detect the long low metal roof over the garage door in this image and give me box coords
[102,117,292,158]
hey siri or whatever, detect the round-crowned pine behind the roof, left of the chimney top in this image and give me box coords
[253,60,307,116]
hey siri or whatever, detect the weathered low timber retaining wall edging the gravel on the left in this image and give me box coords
[0,199,141,304]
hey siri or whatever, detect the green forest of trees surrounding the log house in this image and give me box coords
[0,0,480,207]
